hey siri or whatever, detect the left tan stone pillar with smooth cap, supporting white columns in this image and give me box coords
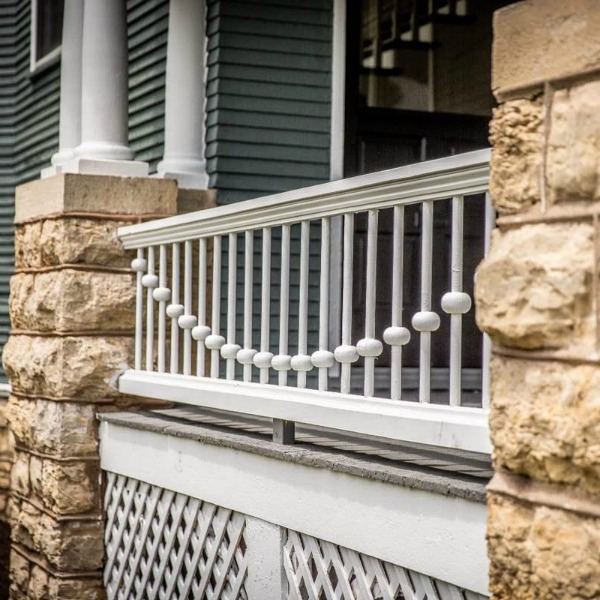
[3,174,177,600]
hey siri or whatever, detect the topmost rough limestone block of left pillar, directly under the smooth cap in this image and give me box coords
[15,217,133,269]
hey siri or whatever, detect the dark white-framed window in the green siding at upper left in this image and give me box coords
[30,0,64,73]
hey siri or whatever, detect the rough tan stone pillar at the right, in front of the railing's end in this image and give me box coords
[475,0,600,600]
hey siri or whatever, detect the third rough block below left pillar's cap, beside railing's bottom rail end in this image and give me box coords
[2,335,133,400]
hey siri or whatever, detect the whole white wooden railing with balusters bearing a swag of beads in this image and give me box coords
[119,151,494,452]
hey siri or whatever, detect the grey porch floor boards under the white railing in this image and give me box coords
[99,405,492,502]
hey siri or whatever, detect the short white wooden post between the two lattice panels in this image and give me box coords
[244,516,284,600]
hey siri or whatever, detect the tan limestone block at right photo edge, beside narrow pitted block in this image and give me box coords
[546,81,600,202]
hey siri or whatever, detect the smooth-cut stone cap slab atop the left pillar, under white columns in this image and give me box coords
[15,174,177,224]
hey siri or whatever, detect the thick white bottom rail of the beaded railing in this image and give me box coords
[119,370,491,453]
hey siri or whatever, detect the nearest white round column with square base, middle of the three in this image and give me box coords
[65,0,148,176]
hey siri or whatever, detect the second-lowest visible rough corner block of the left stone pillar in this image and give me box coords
[11,502,104,572]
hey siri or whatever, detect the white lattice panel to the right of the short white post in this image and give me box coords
[283,530,484,600]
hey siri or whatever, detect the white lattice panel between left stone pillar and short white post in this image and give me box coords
[104,473,247,600]
